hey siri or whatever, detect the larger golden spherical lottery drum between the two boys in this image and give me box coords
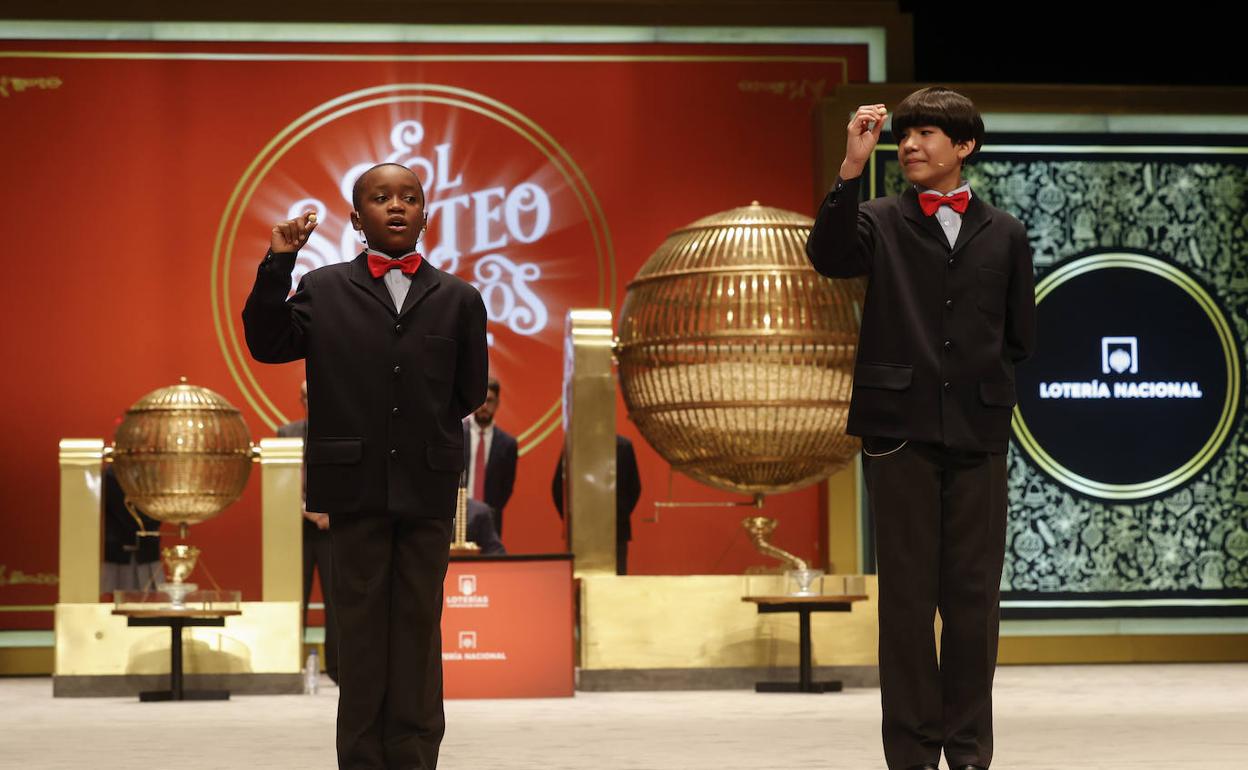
[617,203,861,494]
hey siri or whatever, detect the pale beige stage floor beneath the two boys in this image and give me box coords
[0,664,1248,770]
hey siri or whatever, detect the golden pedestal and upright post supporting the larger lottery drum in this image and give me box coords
[564,309,877,690]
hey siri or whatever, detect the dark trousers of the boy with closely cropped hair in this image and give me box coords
[329,514,453,770]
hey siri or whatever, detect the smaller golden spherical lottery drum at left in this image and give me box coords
[112,377,253,524]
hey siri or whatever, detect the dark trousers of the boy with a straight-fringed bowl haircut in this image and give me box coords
[862,439,1007,770]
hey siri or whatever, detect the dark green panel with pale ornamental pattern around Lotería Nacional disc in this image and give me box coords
[869,135,1248,616]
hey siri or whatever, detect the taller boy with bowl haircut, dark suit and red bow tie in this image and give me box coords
[806,87,1035,770]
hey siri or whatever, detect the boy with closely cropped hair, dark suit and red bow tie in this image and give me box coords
[242,163,488,770]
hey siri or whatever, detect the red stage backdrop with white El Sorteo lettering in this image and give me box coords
[0,41,866,628]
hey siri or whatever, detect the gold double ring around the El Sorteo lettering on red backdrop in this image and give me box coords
[211,84,615,454]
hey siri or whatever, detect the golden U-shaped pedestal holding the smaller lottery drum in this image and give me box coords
[52,438,303,696]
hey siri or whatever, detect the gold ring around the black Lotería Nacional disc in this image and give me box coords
[1011,252,1239,500]
